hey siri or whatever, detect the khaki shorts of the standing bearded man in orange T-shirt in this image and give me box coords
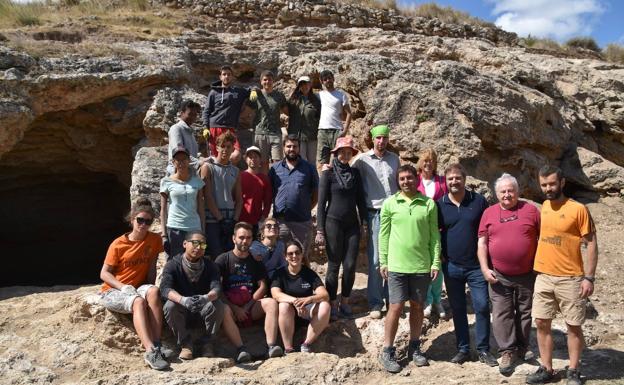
[531,274,587,326]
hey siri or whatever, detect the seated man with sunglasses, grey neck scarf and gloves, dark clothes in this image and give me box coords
[160,231,224,360]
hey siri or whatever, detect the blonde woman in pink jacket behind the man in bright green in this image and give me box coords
[416,148,448,318]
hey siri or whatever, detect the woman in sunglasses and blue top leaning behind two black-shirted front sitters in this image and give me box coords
[249,218,286,282]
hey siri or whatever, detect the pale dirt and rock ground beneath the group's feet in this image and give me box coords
[0,198,624,385]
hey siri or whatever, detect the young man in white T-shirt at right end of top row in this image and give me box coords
[316,70,351,164]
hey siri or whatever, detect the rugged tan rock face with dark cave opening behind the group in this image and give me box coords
[0,0,624,283]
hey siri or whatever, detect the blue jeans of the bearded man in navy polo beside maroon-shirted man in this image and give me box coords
[442,262,490,353]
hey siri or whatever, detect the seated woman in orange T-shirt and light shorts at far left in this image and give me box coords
[100,198,169,370]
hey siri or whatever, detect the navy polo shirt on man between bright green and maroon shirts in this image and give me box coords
[436,190,488,267]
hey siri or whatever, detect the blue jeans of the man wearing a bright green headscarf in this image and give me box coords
[366,210,388,310]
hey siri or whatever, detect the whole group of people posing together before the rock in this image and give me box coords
[95,66,597,384]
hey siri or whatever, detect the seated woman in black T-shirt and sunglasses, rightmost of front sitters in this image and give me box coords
[271,241,331,353]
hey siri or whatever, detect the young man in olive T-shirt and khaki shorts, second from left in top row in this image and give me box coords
[249,71,288,172]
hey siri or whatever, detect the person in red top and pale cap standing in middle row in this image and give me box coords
[240,146,273,237]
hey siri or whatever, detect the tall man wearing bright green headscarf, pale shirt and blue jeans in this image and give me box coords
[353,125,401,318]
